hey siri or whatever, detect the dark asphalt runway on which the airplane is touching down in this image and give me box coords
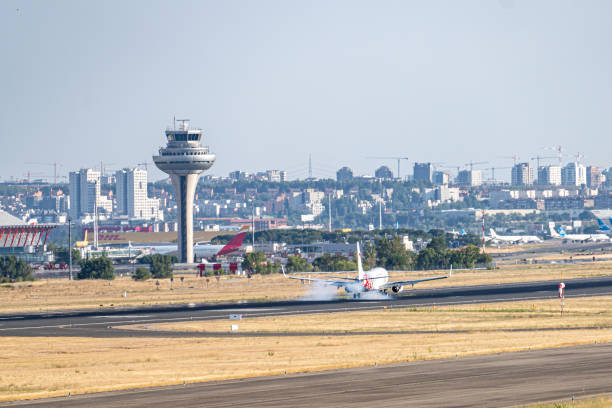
[0,276,612,337]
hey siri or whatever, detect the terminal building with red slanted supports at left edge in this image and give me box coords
[0,210,55,263]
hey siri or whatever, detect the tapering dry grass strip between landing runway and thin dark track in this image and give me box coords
[140,296,612,334]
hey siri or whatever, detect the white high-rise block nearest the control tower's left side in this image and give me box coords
[115,169,159,220]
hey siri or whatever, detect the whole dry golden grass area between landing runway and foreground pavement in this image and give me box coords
[0,297,612,400]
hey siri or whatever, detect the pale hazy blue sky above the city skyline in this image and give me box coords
[0,0,612,180]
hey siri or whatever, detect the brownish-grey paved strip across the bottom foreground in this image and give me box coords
[0,344,612,408]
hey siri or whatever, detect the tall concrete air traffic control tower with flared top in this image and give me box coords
[153,119,216,263]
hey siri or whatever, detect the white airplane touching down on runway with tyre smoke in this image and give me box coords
[281,242,448,299]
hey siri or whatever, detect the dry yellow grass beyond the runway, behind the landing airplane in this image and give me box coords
[0,262,612,313]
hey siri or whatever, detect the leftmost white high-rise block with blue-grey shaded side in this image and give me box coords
[70,169,113,219]
